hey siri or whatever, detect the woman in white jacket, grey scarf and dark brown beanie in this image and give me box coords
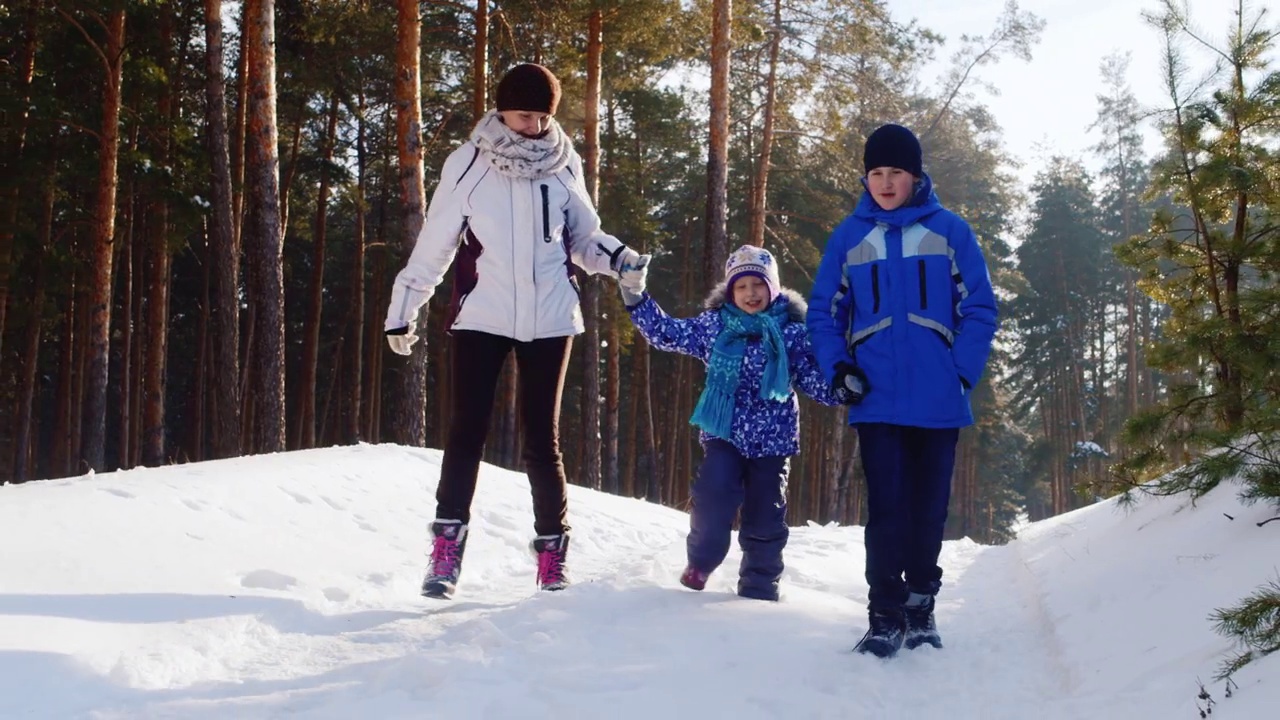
[385,64,644,598]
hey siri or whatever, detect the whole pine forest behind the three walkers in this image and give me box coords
[0,0,1280,542]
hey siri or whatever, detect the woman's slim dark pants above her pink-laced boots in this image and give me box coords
[435,331,573,536]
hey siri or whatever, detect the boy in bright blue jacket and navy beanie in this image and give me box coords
[806,124,996,657]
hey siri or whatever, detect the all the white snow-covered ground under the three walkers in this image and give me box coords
[0,445,1280,720]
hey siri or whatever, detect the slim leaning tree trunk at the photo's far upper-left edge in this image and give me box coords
[0,0,44,357]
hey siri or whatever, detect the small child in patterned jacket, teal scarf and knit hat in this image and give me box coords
[621,245,837,601]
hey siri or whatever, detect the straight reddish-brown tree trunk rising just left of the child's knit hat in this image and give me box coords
[703,0,733,287]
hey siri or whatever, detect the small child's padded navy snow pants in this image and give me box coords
[689,439,790,600]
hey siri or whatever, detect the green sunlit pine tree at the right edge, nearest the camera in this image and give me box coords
[1121,1,1280,492]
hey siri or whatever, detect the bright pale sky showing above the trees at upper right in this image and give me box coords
[888,0,1239,186]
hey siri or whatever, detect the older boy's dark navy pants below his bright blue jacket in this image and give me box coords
[855,423,960,611]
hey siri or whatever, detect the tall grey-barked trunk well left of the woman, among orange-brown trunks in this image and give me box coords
[205,0,241,457]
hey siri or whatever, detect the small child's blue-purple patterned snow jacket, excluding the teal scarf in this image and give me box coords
[627,282,838,459]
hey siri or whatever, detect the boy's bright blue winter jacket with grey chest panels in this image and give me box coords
[806,176,997,428]
